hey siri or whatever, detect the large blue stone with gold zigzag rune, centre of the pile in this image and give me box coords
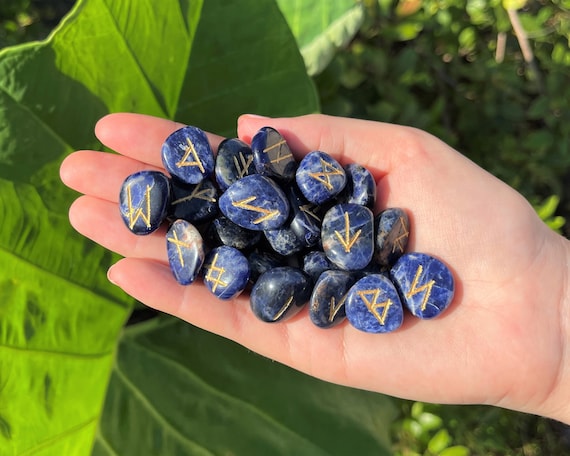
[219,174,289,231]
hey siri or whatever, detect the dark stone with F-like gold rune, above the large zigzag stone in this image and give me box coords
[214,138,255,191]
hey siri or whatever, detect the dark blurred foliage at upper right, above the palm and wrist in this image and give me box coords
[316,0,570,202]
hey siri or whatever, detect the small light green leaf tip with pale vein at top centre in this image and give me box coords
[277,0,364,76]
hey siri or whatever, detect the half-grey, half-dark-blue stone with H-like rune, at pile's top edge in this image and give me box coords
[251,127,297,182]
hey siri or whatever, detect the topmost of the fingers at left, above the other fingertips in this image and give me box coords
[95,113,223,167]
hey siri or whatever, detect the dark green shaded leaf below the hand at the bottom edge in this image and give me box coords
[94,317,394,456]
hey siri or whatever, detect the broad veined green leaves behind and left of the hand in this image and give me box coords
[0,0,393,456]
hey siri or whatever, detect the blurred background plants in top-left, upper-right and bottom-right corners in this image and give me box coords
[0,0,570,456]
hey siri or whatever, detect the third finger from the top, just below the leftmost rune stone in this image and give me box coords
[69,196,168,263]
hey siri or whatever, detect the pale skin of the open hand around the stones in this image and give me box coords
[61,114,570,424]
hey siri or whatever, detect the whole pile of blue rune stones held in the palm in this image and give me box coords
[119,126,454,333]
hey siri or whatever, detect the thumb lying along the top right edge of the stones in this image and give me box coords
[238,114,430,179]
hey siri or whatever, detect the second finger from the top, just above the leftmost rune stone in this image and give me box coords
[59,150,165,203]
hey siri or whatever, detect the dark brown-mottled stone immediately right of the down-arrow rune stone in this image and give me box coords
[374,207,410,266]
